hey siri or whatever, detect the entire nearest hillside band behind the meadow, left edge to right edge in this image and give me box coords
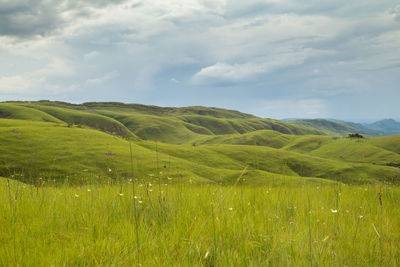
[0,119,400,184]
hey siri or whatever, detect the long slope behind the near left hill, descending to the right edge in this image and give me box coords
[138,143,400,183]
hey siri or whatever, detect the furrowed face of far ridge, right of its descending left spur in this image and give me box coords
[88,103,322,141]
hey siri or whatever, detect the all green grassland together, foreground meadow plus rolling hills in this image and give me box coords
[0,101,400,266]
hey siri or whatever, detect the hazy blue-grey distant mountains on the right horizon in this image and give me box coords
[282,119,400,136]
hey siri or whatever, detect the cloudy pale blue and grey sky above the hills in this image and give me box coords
[0,0,400,122]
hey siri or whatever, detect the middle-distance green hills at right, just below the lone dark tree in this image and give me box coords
[197,130,400,171]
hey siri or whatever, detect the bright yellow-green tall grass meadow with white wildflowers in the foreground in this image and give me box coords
[0,178,400,266]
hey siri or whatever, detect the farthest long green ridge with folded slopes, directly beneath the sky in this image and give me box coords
[7,101,323,144]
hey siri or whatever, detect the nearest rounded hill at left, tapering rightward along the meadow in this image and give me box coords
[0,119,324,186]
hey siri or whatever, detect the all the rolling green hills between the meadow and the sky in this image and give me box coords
[0,101,400,184]
